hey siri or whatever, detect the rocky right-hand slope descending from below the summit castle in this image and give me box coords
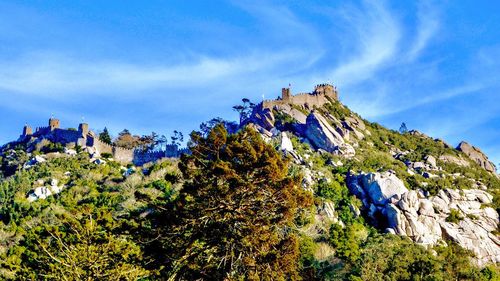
[249,88,500,266]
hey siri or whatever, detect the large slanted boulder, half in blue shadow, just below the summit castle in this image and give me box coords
[305,111,344,152]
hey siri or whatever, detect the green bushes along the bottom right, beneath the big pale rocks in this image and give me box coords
[348,235,497,281]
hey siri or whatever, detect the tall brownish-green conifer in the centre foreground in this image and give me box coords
[158,124,312,280]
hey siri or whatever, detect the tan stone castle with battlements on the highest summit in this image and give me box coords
[262,84,339,110]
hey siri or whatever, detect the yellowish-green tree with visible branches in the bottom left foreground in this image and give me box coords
[17,212,149,280]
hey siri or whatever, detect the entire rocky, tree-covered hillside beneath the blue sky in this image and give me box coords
[0,84,500,280]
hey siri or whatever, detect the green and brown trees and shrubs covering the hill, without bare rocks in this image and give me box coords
[0,100,500,281]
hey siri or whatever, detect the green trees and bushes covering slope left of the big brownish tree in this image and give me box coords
[0,149,180,280]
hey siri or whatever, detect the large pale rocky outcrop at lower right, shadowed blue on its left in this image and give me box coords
[348,173,500,265]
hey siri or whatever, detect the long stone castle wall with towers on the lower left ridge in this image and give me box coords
[18,118,188,165]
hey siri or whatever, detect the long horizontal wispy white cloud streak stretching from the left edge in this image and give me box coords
[0,50,308,97]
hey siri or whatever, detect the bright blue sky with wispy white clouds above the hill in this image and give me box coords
[0,0,500,163]
